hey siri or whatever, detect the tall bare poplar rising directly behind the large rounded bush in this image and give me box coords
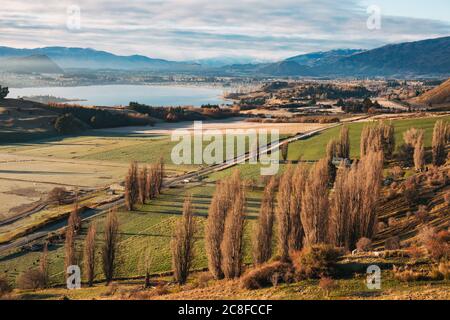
[301,158,329,246]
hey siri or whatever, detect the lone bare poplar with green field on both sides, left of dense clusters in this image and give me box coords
[171,196,196,284]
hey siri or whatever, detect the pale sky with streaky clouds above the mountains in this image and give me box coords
[0,0,450,61]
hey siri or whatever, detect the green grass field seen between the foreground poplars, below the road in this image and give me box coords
[0,184,260,285]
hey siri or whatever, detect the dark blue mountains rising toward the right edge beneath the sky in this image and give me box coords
[223,37,450,77]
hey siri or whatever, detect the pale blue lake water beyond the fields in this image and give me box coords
[8,85,228,106]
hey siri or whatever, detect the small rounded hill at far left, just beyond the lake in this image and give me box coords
[0,54,64,74]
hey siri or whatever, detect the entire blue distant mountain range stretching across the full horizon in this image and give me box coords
[0,37,450,77]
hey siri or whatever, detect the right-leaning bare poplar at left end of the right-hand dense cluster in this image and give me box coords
[252,177,277,265]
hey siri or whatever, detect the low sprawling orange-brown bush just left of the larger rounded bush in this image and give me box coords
[241,261,292,290]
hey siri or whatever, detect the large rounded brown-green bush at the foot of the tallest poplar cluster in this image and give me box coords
[292,244,343,279]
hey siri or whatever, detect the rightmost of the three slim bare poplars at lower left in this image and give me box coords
[102,210,119,284]
